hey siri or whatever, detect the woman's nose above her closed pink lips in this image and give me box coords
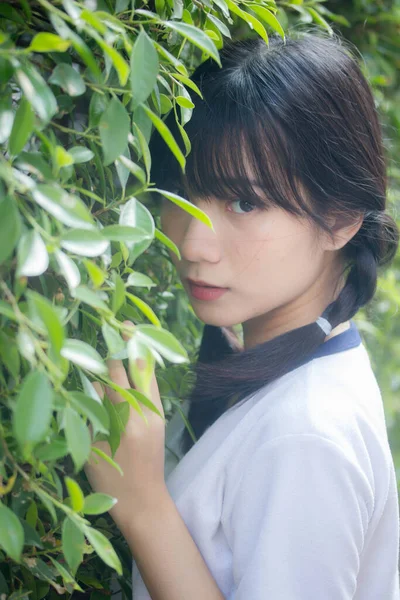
[179,209,222,262]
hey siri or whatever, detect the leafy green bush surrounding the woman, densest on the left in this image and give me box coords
[0,0,400,600]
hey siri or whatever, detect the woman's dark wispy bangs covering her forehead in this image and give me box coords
[148,88,310,216]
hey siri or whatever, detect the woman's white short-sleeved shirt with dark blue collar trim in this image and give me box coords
[132,321,400,600]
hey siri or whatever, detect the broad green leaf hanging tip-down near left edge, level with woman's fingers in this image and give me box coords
[13,371,53,448]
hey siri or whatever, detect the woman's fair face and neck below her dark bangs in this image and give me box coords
[161,180,356,347]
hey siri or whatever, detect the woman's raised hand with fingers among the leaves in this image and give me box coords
[85,321,166,531]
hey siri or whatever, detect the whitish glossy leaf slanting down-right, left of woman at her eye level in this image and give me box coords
[31,183,95,229]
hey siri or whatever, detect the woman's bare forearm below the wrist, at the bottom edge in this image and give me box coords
[116,487,224,600]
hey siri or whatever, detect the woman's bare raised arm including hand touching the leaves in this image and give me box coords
[85,323,223,600]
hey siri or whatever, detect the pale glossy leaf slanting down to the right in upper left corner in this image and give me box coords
[16,63,58,123]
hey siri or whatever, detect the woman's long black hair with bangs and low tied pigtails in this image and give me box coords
[150,28,399,452]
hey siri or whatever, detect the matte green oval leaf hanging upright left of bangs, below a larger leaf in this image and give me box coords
[99,97,130,166]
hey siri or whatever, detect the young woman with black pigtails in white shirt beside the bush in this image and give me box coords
[87,30,400,600]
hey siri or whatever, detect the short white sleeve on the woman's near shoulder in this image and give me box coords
[222,434,374,600]
